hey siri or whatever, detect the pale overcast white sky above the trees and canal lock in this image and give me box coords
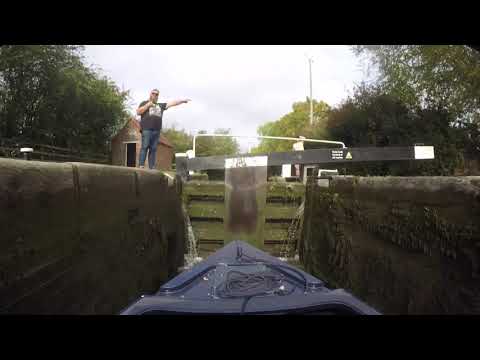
[85,45,366,149]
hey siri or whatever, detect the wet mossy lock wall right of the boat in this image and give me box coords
[300,177,480,314]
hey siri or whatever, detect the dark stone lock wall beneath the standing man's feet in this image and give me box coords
[0,159,185,314]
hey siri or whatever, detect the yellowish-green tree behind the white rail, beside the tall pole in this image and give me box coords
[252,99,330,154]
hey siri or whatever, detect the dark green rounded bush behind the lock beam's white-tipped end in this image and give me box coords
[327,87,462,176]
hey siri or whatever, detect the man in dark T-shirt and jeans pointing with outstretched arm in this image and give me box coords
[137,89,190,169]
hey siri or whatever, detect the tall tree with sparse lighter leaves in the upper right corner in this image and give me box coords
[353,45,480,156]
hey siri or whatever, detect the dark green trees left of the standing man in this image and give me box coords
[0,45,128,152]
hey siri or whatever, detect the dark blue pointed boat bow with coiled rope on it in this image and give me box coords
[121,241,379,315]
